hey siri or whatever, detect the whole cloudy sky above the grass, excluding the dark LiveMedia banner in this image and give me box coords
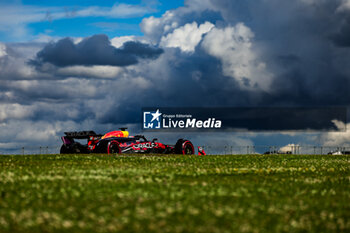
[0,0,350,153]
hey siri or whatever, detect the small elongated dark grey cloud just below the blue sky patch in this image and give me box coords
[30,35,163,67]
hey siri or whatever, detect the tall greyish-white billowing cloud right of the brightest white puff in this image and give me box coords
[202,23,272,91]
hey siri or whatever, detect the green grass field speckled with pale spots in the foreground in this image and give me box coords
[0,155,350,233]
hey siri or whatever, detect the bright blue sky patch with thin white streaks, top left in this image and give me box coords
[0,0,184,42]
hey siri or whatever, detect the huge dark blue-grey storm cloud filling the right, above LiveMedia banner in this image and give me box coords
[101,0,350,123]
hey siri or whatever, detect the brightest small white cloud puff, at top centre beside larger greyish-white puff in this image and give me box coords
[160,22,214,52]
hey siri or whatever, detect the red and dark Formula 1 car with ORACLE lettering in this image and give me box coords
[60,128,195,155]
